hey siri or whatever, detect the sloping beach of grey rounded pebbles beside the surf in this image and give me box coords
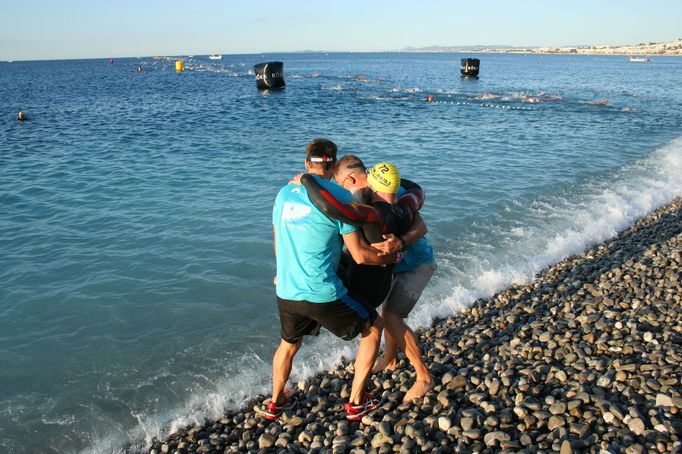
[149,199,682,454]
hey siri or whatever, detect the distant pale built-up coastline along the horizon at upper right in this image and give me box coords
[400,39,682,55]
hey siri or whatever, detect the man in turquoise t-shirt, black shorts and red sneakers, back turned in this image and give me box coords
[262,139,396,421]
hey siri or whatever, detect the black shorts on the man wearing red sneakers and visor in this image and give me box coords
[277,295,377,344]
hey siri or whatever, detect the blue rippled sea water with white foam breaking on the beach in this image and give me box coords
[0,53,682,453]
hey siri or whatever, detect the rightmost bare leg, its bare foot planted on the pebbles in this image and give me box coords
[383,311,435,402]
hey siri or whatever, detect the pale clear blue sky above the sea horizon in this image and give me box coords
[0,0,682,60]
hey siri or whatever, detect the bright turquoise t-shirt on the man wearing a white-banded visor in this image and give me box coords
[272,175,357,303]
